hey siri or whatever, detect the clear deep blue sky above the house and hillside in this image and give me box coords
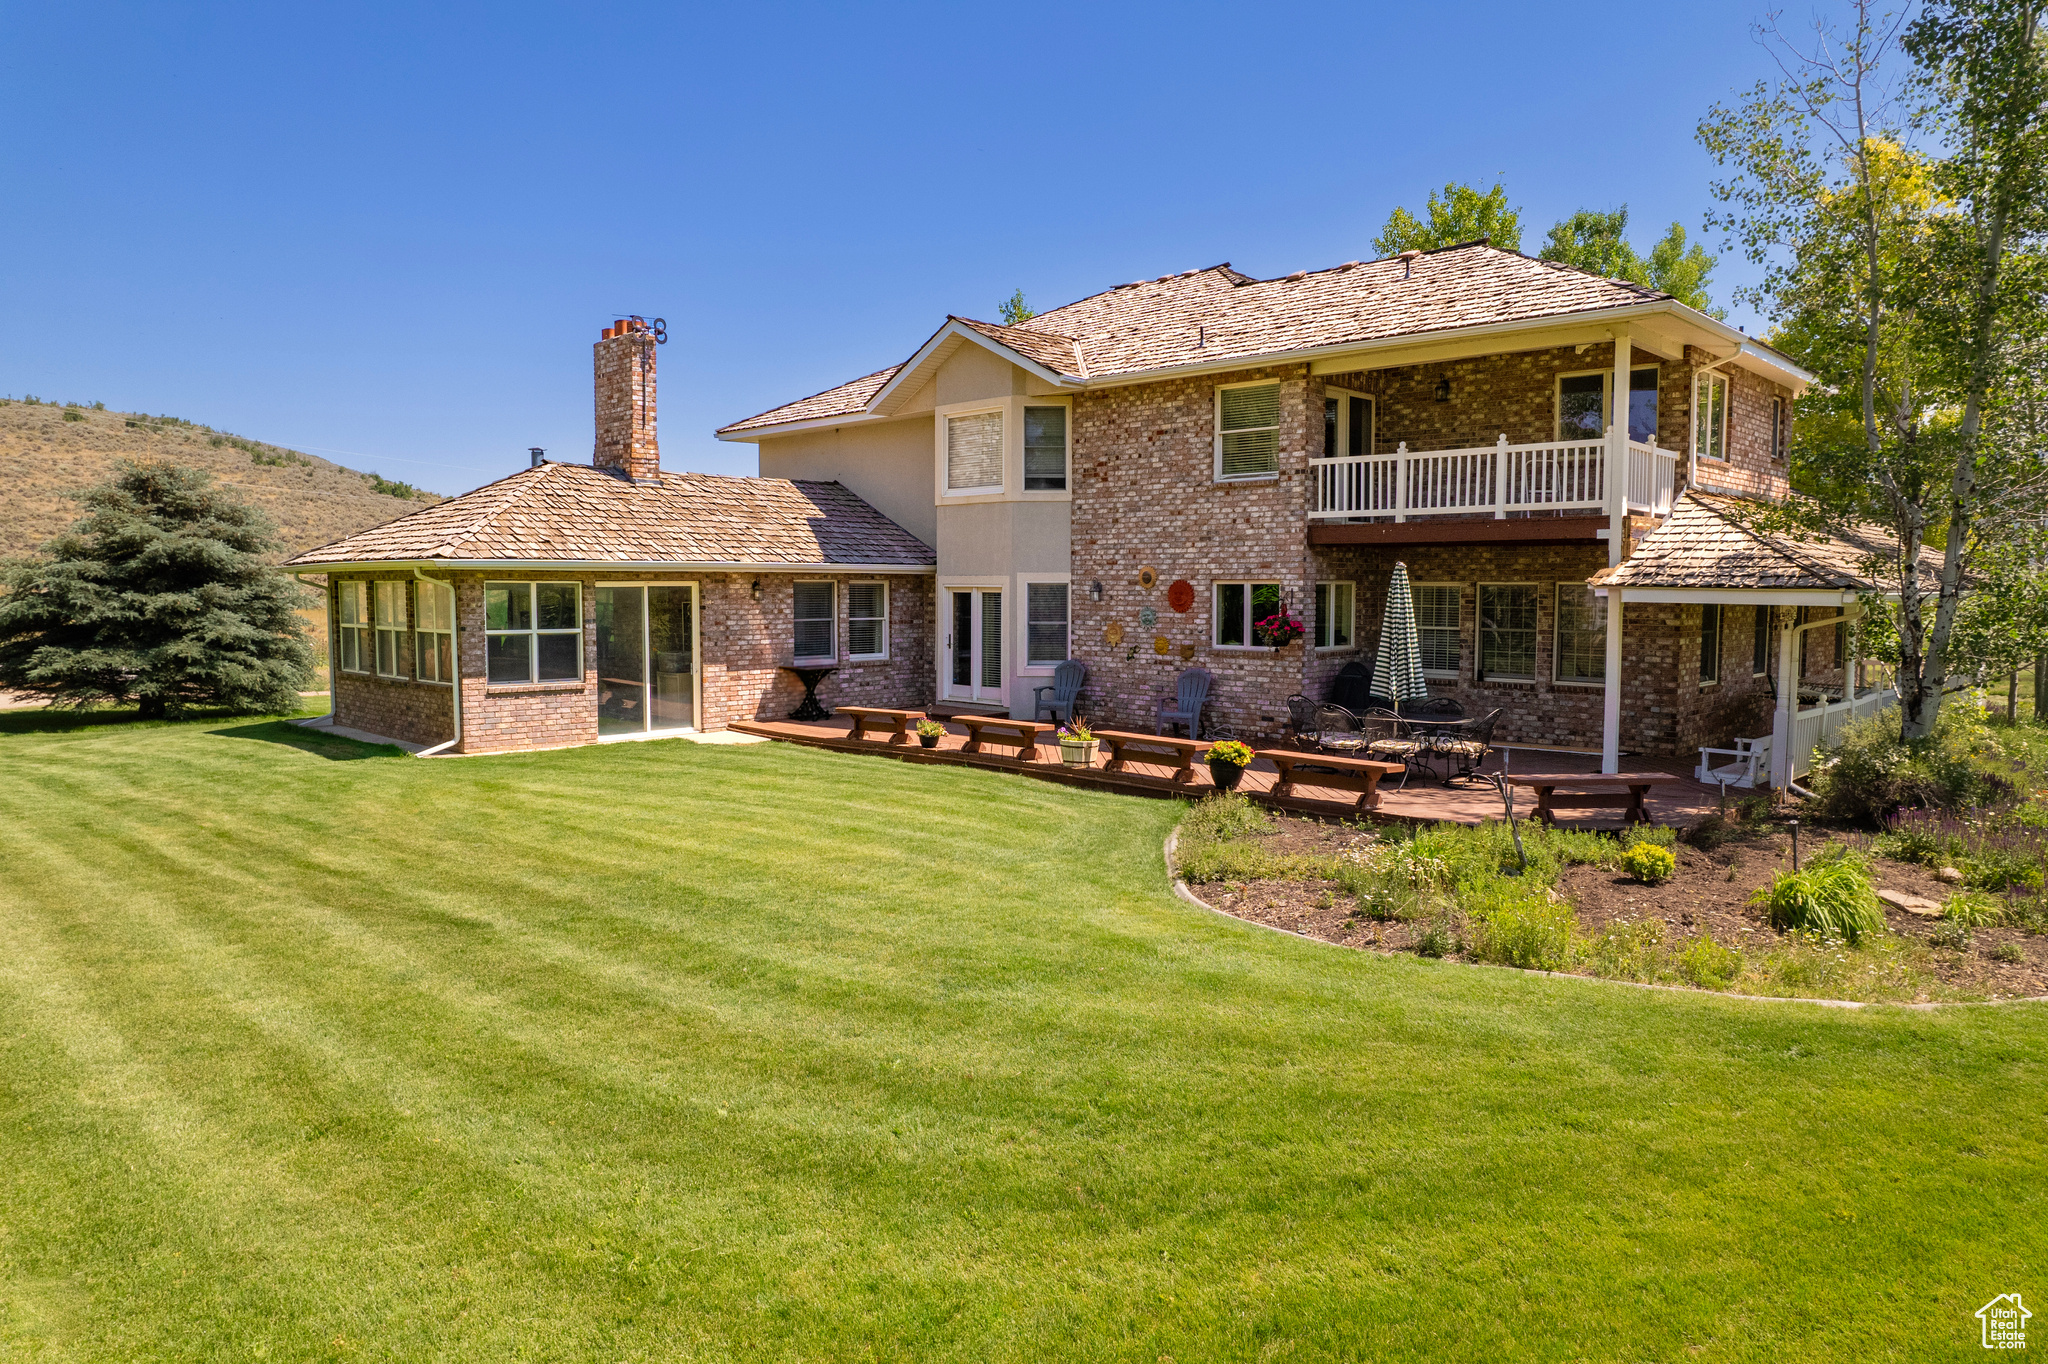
[0,0,1800,492]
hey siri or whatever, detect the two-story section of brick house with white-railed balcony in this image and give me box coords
[719,242,1843,762]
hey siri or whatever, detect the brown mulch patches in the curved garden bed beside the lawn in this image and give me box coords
[1190,817,2048,999]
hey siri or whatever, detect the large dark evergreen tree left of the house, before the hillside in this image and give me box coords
[0,463,313,719]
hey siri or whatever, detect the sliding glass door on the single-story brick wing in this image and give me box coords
[596,584,696,737]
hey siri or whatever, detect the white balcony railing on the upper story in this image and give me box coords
[1309,436,1677,520]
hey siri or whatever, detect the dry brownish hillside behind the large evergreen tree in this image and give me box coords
[0,399,440,557]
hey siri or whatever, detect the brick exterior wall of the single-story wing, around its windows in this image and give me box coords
[330,573,934,754]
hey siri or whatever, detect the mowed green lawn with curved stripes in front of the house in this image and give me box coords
[0,713,2048,1364]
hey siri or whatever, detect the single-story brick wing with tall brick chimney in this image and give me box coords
[289,322,934,754]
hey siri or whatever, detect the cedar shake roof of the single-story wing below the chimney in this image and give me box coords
[287,463,936,569]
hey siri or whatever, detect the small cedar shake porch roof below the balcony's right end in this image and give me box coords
[1587,492,1942,592]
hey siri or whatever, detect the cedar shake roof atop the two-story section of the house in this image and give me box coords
[719,242,1671,434]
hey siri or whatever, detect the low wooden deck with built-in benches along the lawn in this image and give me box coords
[733,719,1720,827]
